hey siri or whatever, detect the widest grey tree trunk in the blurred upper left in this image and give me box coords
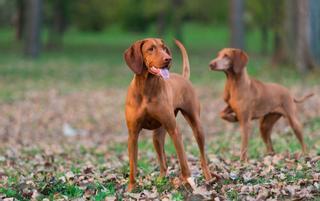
[25,0,42,58]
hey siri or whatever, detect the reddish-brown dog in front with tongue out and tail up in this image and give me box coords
[124,38,211,191]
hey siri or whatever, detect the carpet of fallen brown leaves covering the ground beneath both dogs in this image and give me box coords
[0,87,320,201]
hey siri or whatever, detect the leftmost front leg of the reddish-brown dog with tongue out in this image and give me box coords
[128,128,139,192]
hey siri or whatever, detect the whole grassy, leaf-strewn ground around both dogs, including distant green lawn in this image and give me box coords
[0,24,320,200]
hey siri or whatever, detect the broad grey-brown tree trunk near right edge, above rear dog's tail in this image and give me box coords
[295,0,315,72]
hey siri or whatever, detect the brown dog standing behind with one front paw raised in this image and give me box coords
[210,48,313,161]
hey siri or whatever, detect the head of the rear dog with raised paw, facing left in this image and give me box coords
[209,48,248,73]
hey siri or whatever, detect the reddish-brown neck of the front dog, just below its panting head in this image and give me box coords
[134,70,165,97]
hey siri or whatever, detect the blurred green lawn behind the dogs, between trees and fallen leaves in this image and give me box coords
[0,23,319,101]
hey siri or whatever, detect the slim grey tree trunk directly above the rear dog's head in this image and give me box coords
[230,0,244,49]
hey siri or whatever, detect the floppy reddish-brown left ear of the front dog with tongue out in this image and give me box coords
[124,40,144,75]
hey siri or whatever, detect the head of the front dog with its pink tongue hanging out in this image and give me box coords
[124,38,172,78]
